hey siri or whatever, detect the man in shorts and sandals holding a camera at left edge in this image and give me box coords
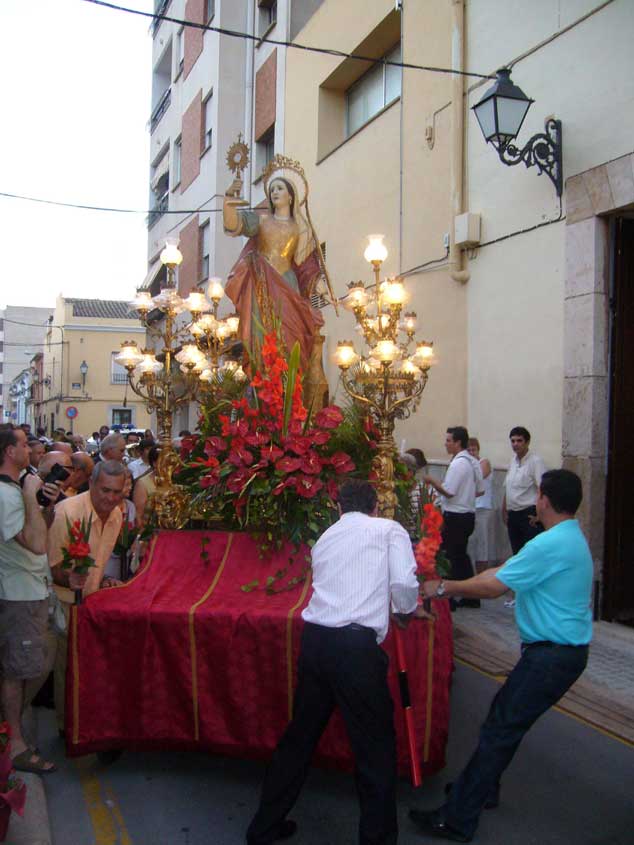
[0,429,59,774]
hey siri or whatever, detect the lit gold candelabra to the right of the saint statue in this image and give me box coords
[336,235,434,519]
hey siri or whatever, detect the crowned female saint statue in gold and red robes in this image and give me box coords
[223,155,330,374]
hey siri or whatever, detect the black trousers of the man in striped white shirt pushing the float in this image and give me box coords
[247,623,398,845]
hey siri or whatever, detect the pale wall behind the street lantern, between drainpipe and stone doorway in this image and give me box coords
[466,0,634,466]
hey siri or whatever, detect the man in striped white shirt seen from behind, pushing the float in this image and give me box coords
[247,480,418,845]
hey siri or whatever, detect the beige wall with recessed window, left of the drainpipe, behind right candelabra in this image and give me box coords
[285,0,467,454]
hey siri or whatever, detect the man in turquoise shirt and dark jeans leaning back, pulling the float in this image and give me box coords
[410,469,593,842]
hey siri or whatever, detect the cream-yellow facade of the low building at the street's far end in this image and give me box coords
[41,297,150,435]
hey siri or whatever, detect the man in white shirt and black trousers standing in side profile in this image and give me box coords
[425,425,484,607]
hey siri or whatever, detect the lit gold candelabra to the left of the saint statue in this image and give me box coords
[115,241,239,528]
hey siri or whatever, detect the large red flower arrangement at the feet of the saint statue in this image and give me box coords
[179,333,355,572]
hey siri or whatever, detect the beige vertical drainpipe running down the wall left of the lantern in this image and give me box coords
[449,0,471,284]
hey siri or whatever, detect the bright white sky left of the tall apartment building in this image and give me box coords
[0,0,153,308]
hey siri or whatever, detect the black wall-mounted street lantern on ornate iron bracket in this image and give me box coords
[472,68,563,197]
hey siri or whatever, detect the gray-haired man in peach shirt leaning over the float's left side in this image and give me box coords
[47,462,125,731]
